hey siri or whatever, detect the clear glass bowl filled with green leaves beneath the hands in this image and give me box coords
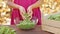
[16,17,38,30]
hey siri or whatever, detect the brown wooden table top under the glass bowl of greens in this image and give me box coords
[11,25,52,34]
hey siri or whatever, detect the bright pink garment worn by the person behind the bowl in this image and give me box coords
[11,0,41,25]
